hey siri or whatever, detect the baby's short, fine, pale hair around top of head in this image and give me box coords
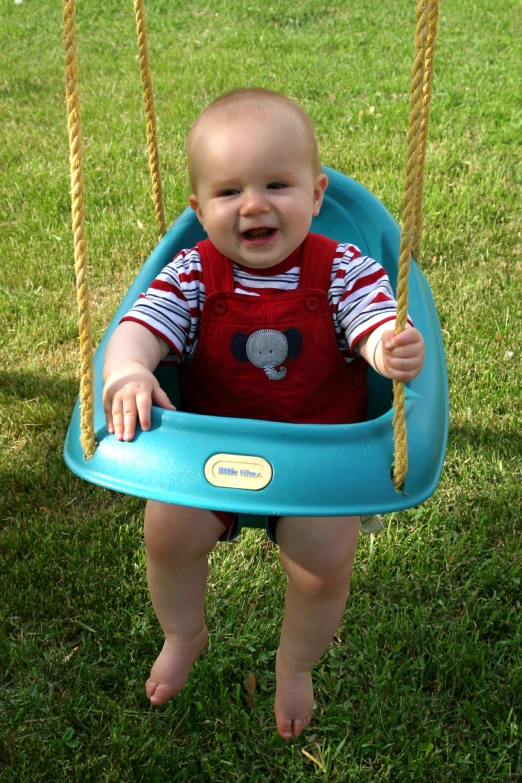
[186,87,321,191]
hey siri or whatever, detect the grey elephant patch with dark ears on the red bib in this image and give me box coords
[230,327,303,381]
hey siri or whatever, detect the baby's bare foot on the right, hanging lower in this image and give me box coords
[274,652,314,739]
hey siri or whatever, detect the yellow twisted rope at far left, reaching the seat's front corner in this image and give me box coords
[63,0,96,459]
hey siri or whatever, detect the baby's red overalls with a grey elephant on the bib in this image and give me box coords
[179,234,368,540]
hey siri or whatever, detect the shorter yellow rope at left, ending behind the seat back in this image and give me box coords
[134,0,166,239]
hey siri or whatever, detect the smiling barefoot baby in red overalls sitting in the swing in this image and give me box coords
[104,88,424,738]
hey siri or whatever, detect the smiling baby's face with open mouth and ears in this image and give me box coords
[189,106,327,269]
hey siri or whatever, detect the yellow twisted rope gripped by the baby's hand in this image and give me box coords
[393,0,430,490]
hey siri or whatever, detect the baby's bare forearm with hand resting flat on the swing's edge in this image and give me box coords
[103,321,176,440]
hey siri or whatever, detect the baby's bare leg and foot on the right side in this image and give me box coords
[274,517,359,739]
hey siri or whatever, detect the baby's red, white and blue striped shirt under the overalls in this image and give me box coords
[122,243,397,362]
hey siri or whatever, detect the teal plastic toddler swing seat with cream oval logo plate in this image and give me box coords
[64,169,448,527]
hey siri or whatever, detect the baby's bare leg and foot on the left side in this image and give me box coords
[145,500,224,704]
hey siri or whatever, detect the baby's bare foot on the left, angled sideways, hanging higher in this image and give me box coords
[145,628,208,705]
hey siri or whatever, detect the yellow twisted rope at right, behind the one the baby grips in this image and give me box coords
[412,0,439,261]
